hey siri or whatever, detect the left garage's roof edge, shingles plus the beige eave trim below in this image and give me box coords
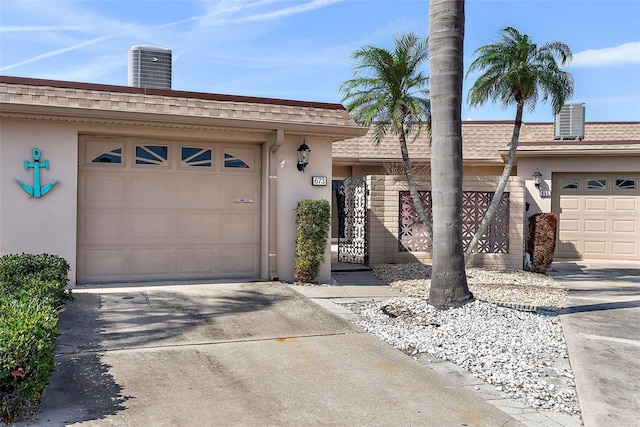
[0,76,366,140]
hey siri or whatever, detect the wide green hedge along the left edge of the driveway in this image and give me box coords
[0,254,71,423]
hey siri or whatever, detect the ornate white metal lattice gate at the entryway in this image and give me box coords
[336,176,368,264]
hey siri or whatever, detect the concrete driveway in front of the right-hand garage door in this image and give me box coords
[550,261,640,427]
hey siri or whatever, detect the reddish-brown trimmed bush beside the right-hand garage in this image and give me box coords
[527,212,558,274]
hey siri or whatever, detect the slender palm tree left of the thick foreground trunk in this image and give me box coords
[340,33,433,241]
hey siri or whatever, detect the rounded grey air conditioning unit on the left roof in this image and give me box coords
[128,46,171,89]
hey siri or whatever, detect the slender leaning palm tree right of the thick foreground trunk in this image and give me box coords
[465,27,573,261]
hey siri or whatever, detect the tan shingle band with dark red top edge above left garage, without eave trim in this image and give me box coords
[0,76,363,136]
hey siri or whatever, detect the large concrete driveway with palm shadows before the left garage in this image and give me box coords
[27,282,520,426]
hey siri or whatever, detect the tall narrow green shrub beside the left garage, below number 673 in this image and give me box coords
[295,199,331,282]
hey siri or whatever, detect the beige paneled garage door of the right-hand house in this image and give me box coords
[553,173,640,260]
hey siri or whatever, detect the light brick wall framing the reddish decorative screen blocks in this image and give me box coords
[367,175,525,270]
